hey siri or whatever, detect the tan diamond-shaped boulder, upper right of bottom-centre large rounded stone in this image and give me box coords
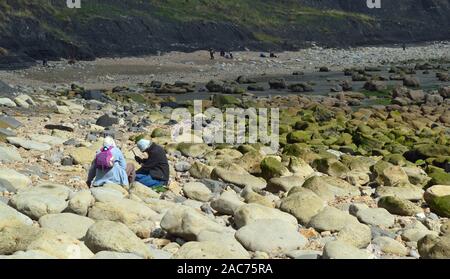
[280,187,326,225]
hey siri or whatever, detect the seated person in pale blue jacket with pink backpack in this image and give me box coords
[86,137,129,187]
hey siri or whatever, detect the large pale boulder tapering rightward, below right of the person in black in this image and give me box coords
[160,206,230,241]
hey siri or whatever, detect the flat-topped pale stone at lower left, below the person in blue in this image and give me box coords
[39,213,95,239]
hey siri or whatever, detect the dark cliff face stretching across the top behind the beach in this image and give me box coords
[0,0,450,68]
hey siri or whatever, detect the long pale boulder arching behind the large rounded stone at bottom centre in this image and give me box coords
[234,203,298,228]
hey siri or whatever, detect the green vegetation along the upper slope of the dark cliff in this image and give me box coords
[0,0,374,44]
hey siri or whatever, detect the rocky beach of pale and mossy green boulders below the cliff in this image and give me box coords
[0,42,450,259]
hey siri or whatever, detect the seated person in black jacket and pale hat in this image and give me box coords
[135,139,169,187]
